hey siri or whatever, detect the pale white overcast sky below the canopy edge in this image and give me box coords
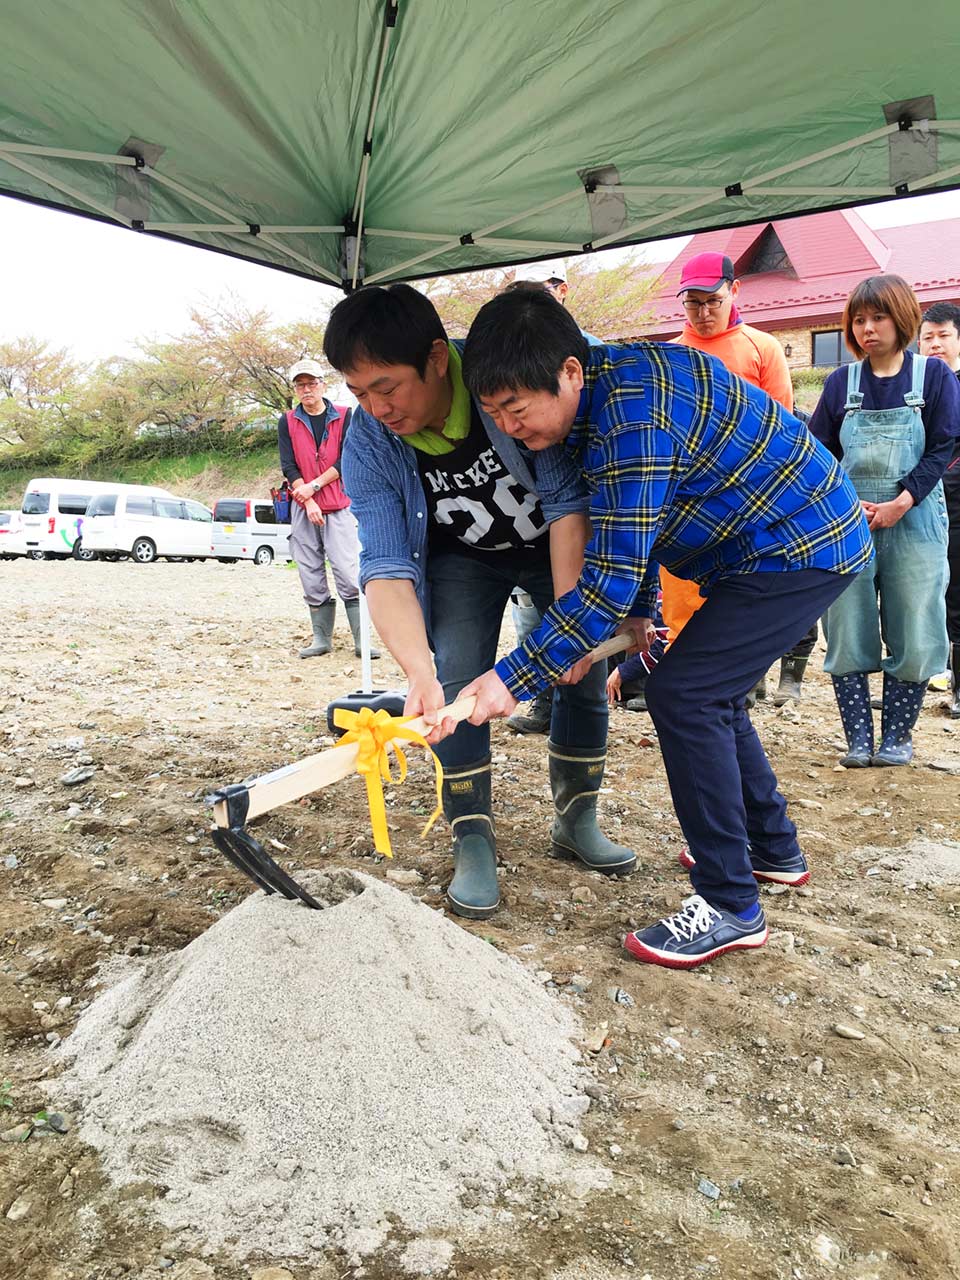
[0,184,960,360]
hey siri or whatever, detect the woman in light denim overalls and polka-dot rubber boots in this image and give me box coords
[810,275,960,768]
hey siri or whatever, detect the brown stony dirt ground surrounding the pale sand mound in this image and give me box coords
[0,561,960,1280]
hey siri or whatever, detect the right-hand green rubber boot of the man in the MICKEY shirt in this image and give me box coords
[547,742,636,876]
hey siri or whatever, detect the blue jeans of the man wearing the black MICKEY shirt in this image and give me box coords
[426,547,608,768]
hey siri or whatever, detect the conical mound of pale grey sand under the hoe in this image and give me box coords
[58,872,605,1257]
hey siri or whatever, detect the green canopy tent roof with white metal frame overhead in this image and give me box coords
[0,0,960,288]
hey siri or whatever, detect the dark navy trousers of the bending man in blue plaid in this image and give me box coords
[646,570,851,911]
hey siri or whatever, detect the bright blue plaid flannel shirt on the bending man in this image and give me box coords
[497,343,873,699]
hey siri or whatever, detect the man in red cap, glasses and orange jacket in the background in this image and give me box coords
[660,253,817,707]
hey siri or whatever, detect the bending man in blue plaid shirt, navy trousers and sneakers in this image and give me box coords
[463,293,873,969]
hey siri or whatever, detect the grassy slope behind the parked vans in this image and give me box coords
[0,444,282,508]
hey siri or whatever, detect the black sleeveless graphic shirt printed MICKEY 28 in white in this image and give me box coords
[417,406,547,554]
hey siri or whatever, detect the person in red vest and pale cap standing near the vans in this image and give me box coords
[278,360,380,658]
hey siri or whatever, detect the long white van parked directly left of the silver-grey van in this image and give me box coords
[83,485,214,564]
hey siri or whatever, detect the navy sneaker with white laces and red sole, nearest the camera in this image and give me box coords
[623,893,767,969]
